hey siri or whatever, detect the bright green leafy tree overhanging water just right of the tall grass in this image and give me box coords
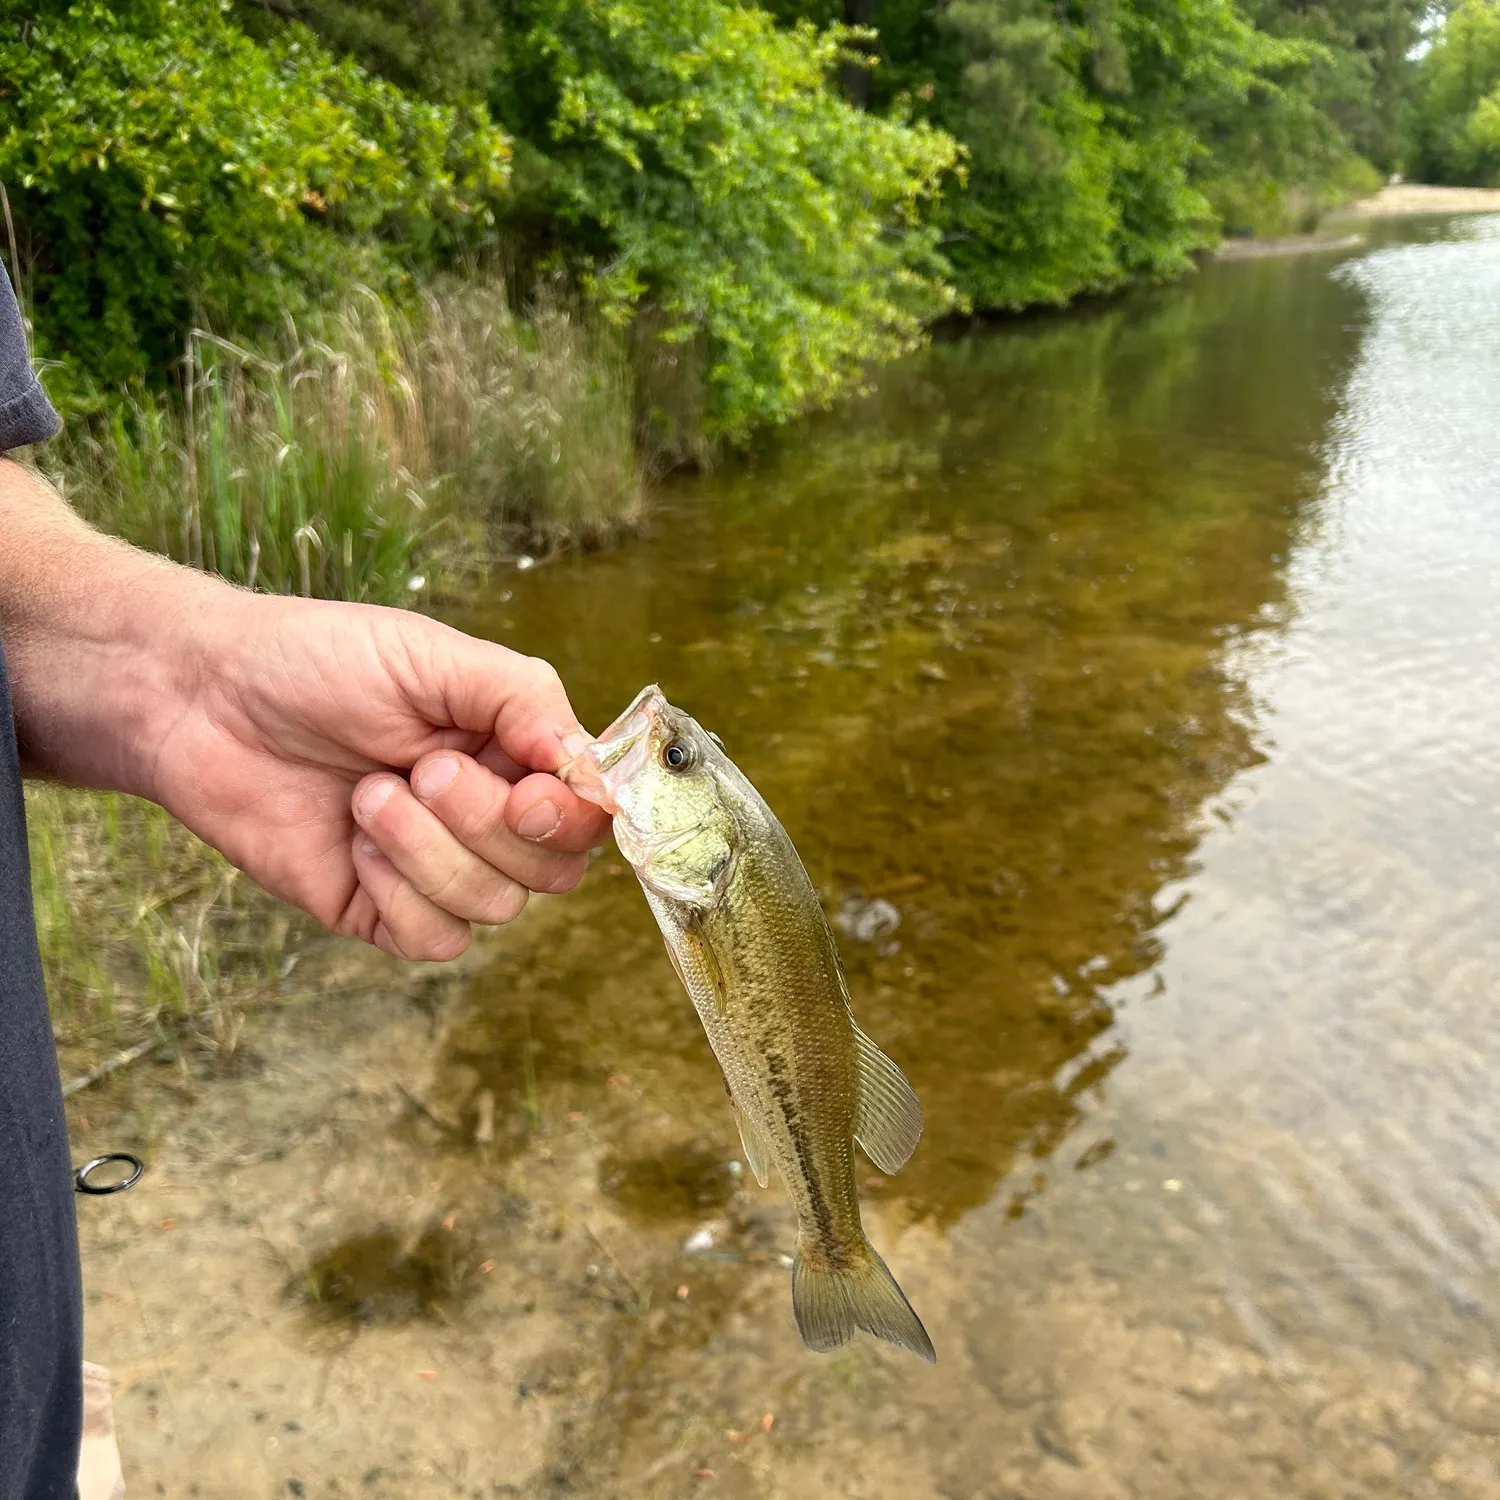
[495,0,956,438]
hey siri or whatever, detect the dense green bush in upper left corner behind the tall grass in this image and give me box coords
[0,0,509,387]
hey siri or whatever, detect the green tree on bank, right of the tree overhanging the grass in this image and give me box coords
[906,0,1332,308]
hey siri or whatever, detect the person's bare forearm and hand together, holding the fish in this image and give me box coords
[0,458,606,960]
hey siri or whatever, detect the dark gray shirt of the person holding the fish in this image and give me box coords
[0,272,83,1500]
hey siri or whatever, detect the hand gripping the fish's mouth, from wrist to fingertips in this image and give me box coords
[147,590,608,960]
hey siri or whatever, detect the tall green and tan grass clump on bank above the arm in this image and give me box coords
[53,284,642,603]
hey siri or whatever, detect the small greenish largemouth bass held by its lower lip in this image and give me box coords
[558,684,938,1362]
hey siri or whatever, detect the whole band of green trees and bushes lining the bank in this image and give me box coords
[0,0,1440,438]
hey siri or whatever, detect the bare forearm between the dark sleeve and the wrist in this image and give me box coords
[0,459,225,797]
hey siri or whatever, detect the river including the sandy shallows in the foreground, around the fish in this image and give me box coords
[75,218,1500,1500]
